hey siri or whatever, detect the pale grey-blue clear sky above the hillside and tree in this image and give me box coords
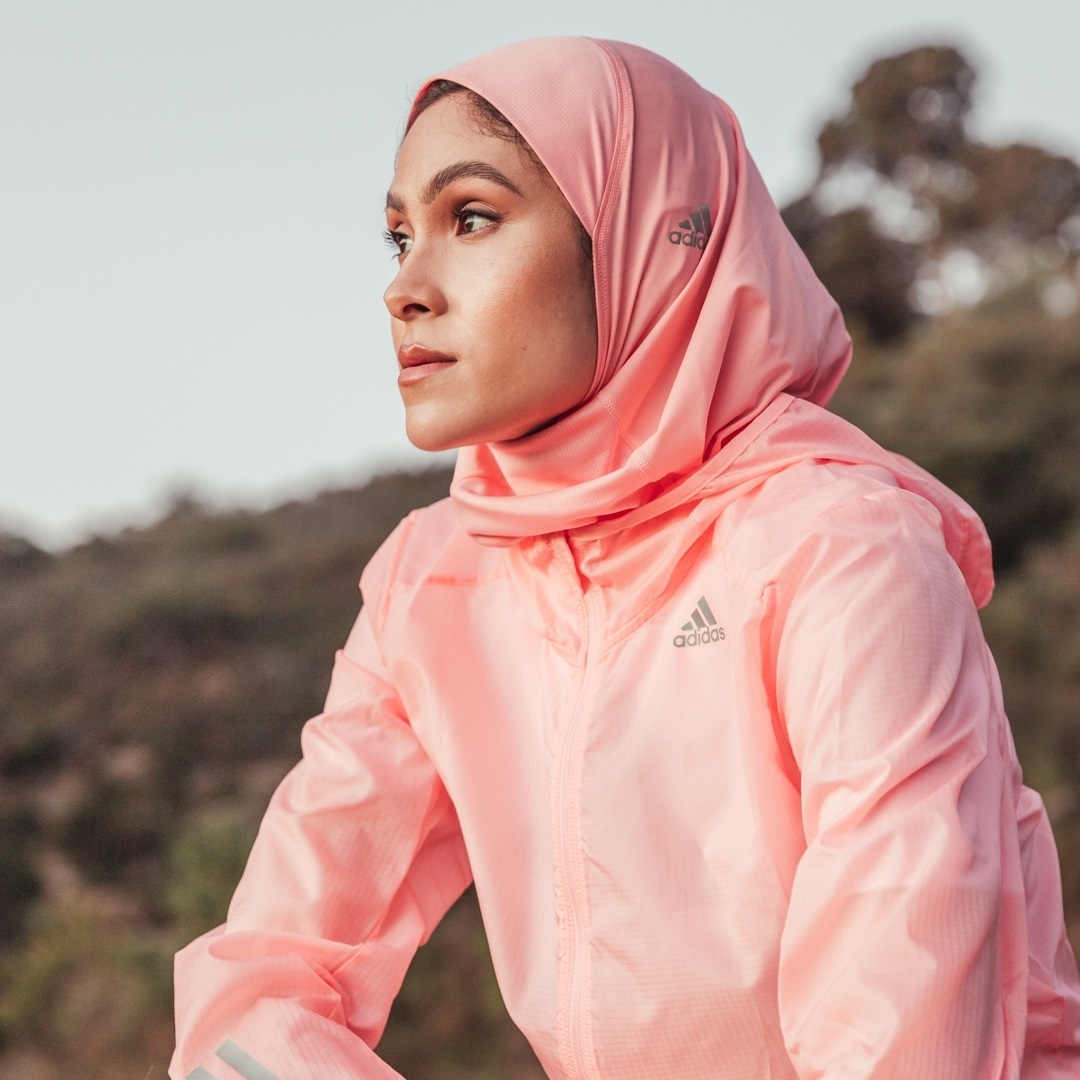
[6,0,1080,548]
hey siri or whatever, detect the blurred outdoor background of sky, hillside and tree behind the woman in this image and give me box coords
[0,0,1080,1080]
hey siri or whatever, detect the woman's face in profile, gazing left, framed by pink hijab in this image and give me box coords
[384,93,596,450]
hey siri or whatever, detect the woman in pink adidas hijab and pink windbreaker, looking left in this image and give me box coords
[171,38,1080,1080]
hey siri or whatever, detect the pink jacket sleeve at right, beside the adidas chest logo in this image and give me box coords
[766,489,1032,1080]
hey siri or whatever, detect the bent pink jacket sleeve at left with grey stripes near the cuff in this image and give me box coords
[168,544,471,1080]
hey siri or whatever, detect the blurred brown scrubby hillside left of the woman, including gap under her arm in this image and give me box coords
[0,471,552,1080]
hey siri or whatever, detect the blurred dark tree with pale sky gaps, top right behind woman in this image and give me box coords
[783,45,1080,342]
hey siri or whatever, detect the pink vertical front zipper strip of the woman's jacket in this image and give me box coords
[555,541,599,1080]
